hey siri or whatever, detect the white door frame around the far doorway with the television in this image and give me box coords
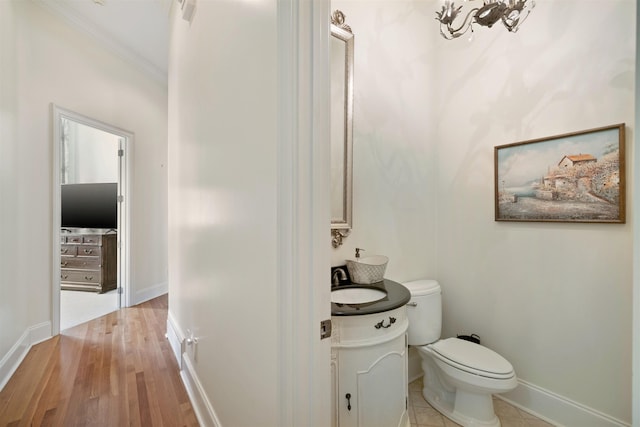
[51,104,134,336]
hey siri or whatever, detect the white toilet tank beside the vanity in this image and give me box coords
[402,279,442,345]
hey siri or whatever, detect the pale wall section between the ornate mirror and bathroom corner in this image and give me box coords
[328,0,437,281]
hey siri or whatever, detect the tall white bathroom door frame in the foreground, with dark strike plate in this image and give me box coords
[277,0,331,427]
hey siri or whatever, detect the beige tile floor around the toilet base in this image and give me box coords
[409,378,553,427]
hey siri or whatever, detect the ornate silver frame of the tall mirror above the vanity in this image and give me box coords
[330,10,354,248]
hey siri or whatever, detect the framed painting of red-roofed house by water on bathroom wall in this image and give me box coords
[494,123,625,224]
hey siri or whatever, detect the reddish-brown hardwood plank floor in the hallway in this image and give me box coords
[0,295,198,427]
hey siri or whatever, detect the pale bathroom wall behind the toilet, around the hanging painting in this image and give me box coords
[435,0,635,422]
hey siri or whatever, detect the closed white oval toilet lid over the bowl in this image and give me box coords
[430,338,514,378]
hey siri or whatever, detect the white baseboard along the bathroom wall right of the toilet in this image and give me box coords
[496,380,631,427]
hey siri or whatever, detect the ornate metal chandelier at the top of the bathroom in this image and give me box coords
[436,0,536,40]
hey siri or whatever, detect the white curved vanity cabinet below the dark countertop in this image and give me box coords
[331,305,409,427]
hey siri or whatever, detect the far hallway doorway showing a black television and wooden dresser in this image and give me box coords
[52,105,133,335]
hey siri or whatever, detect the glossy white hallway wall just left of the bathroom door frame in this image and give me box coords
[169,0,280,426]
